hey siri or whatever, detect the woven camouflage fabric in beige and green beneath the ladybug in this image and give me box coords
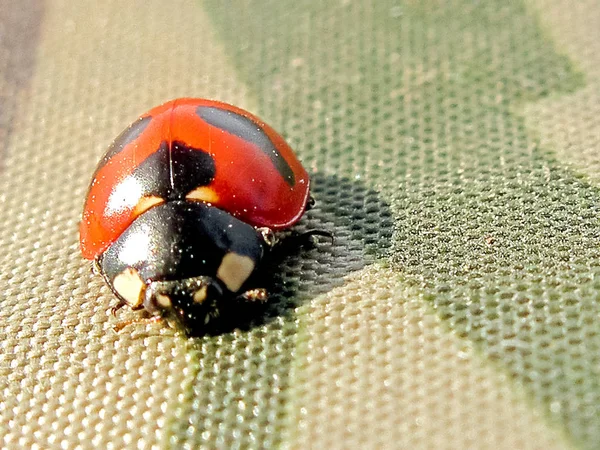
[0,0,600,449]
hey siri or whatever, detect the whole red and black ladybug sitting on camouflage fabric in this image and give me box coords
[80,98,310,328]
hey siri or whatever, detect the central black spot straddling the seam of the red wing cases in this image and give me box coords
[132,141,215,200]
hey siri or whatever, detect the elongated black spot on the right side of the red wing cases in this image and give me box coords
[196,106,296,186]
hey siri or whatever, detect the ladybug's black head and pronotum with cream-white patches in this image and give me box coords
[99,201,266,329]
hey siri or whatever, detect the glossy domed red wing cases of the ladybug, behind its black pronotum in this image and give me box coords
[80,98,309,259]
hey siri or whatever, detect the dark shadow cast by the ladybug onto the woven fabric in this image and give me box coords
[188,174,393,336]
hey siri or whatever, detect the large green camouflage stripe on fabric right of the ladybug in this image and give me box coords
[205,0,600,446]
